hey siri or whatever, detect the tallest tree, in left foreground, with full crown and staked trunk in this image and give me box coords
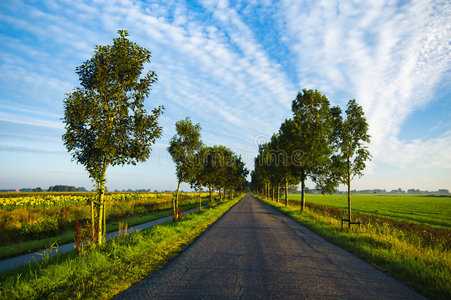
[63,30,163,245]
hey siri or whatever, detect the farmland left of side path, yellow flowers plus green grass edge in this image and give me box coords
[0,192,215,260]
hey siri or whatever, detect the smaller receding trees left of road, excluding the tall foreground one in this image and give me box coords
[168,118,248,220]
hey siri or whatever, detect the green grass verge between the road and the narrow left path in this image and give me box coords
[0,197,241,299]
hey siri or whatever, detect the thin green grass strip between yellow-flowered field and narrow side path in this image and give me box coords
[0,200,210,259]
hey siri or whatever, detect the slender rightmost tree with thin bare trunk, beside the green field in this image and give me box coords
[328,99,371,226]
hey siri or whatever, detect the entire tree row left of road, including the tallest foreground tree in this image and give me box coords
[63,30,247,245]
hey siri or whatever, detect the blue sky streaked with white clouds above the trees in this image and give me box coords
[0,0,451,190]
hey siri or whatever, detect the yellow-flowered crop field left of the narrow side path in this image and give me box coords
[0,194,214,246]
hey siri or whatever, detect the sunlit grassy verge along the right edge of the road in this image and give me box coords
[263,195,451,299]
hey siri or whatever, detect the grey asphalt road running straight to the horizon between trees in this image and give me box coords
[116,195,423,299]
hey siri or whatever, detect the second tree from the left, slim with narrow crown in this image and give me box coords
[168,117,203,220]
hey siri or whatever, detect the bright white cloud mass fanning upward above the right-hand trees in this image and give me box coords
[281,0,451,169]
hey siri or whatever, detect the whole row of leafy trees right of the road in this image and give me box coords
[251,89,371,224]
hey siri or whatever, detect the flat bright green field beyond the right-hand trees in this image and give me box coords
[290,194,451,229]
